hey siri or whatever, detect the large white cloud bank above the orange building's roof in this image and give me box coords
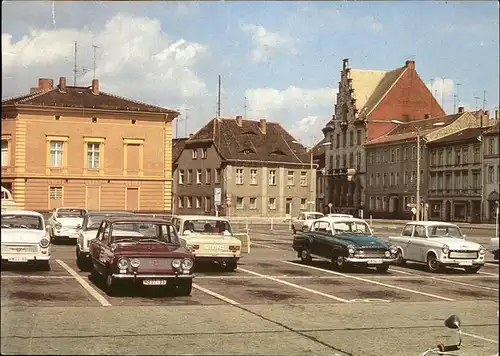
[2,13,208,108]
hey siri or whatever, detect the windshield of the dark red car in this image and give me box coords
[111,222,179,245]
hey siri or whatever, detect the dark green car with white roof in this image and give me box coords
[293,217,397,272]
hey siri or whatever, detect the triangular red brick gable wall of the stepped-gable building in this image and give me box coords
[367,63,446,141]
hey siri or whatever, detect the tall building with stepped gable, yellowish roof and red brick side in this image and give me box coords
[323,59,445,215]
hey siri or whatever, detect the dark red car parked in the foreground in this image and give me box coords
[89,216,194,296]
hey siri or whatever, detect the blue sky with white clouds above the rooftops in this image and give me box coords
[2,1,499,145]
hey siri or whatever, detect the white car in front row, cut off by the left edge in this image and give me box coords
[2,210,50,271]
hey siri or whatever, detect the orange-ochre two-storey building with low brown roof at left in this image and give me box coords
[1,77,179,212]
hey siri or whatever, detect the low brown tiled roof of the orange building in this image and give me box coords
[2,86,179,115]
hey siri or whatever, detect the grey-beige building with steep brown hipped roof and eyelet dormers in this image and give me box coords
[174,116,316,217]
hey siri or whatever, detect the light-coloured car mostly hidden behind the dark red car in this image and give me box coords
[76,211,134,271]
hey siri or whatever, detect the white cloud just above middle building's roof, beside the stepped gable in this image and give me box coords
[245,86,338,145]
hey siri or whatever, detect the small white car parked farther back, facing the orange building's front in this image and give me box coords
[47,207,87,242]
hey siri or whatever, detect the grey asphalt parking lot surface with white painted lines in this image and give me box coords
[1,228,499,356]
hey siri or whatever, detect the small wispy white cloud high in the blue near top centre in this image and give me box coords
[241,24,298,62]
